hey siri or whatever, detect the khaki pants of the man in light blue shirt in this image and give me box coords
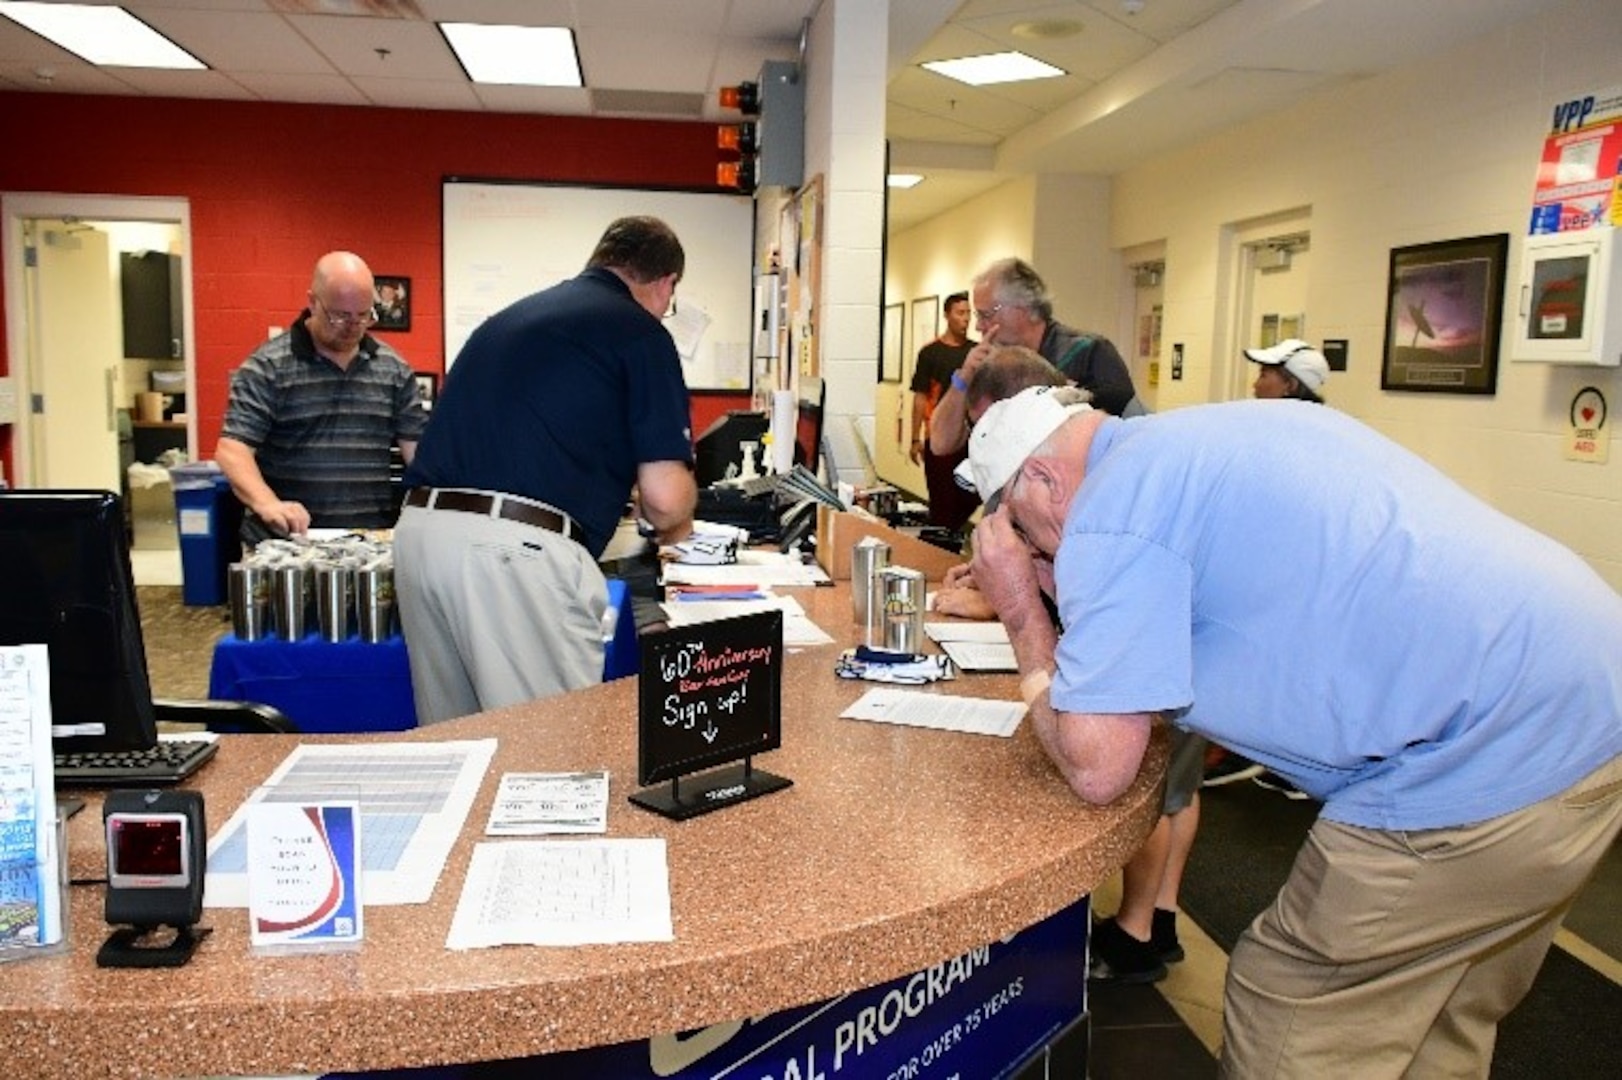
[1221,757,1622,1080]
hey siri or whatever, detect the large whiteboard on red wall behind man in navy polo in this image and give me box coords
[441,178,754,389]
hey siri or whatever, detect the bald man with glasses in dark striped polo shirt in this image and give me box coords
[214,251,428,545]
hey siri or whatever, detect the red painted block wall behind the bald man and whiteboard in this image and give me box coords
[0,92,740,475]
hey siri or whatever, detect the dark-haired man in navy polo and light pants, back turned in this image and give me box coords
[394,217,697,723]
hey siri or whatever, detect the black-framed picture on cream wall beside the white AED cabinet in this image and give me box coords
[1380,232,1510,394]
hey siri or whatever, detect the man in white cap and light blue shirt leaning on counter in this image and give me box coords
[968,391,1622,1077]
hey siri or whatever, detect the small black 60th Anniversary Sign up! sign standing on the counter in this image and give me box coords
[631,611,788,817]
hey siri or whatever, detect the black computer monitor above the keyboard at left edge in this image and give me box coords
[0,491,157,752]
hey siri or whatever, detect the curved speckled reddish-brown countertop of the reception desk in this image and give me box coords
[0,585,1165,1077]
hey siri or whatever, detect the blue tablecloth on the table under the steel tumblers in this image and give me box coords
[208,579,639,733]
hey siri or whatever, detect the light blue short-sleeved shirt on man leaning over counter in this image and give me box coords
[1051,401,1622,829]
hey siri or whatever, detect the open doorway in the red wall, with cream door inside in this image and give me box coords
[0,193,196,585]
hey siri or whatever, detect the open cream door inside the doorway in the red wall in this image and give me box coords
[23,219,123,491]
